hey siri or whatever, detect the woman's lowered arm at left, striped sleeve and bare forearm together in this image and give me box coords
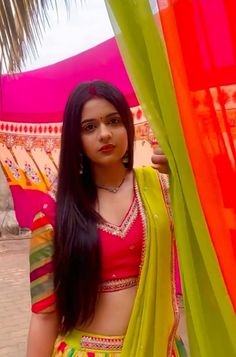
[27,212,59,357]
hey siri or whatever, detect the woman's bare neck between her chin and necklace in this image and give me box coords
[92,163,128,187]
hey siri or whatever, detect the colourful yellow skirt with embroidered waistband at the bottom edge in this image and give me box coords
[52,329,187,357]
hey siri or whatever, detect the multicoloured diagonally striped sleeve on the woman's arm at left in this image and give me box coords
[30,213,55,313]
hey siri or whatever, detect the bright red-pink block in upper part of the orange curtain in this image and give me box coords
[173,0,236,90]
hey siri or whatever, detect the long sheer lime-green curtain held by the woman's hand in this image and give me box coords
[106,0,236,357]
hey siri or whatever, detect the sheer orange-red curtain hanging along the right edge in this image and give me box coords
[157,0,236,309]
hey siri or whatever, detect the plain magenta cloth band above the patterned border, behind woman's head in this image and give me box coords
[0,38,138,123]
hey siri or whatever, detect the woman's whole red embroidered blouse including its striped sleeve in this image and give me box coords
[30,186,145,313]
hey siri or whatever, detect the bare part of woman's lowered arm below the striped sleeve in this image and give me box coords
[27,312,59,357]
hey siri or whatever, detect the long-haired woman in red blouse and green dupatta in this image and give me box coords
[28,81,186,357]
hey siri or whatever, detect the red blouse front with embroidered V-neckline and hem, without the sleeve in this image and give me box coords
[97,184,145,292]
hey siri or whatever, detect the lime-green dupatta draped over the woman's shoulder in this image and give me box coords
[121,167,176,357]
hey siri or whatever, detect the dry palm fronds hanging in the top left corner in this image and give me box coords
[0,0,73,72]
